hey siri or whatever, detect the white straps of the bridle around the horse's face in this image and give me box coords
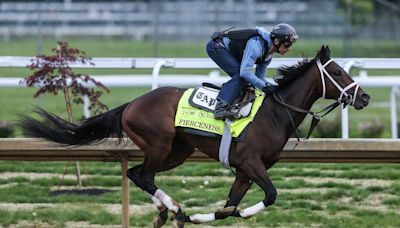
[317,59,360,105]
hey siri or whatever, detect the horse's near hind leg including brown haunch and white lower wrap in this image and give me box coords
[121,87,192,226]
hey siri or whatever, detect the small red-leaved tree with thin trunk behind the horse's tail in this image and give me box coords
[22,42,109,188]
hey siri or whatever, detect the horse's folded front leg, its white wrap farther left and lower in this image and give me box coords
[186,171,252,224]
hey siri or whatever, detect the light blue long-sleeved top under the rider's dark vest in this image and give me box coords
[223,27,272,89]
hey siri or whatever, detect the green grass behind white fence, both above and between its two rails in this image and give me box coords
[0,38,400,77]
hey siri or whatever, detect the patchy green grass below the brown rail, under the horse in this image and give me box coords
[0,162,400,227]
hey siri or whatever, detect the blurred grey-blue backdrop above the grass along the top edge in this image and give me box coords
[0,0,400,40]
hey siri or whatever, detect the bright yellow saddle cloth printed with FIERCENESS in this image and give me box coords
[175,88,265,137]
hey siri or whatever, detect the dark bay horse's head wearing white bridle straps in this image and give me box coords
[314,46,369,109]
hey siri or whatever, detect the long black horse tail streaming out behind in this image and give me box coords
[19,103,129,145]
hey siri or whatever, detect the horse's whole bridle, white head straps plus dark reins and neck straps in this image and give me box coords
[273,59,360,145]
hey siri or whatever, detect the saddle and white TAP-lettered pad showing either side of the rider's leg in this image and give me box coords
[189,82,256,119]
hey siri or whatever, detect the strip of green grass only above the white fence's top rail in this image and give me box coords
[0,37,400,58]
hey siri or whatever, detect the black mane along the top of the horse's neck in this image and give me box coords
[274,46,330,87]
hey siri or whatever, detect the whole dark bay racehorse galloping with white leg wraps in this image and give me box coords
[20,46,369,227]
